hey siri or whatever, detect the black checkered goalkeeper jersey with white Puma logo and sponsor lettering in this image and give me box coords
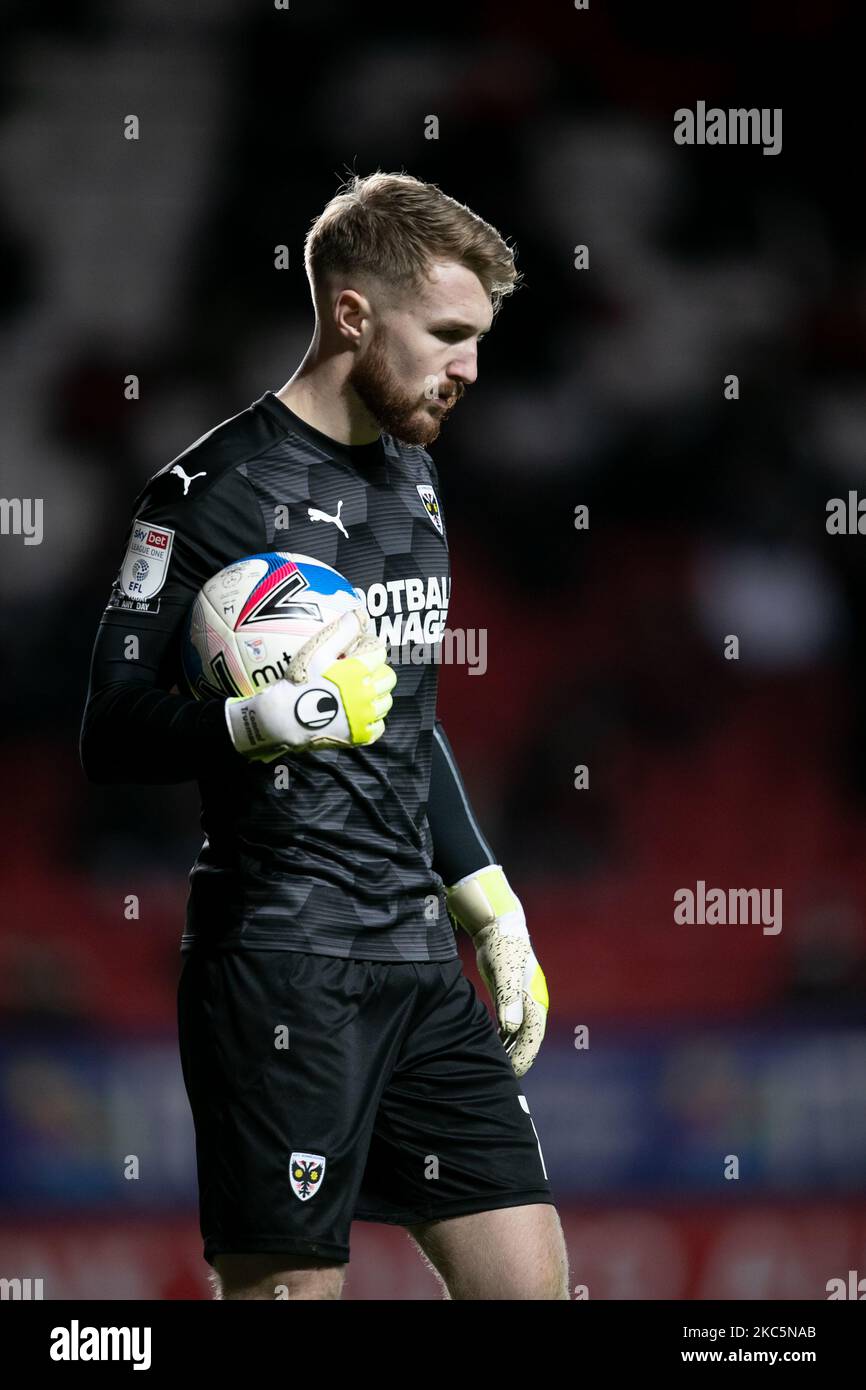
[82,391,467,960]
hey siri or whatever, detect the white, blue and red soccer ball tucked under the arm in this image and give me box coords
[182,550,367,699]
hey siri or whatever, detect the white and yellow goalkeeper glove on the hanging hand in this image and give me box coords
[445,865,550,1076]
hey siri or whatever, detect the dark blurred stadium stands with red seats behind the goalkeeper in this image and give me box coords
[0,0,866,1300]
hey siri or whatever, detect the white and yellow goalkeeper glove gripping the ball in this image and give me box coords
[225,609,398,763]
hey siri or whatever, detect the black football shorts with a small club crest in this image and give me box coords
[178,949,553,1265]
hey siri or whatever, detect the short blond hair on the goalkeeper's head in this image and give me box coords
[304,170,523,314]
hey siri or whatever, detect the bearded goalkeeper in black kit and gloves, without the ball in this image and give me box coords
[81,172,569,1300]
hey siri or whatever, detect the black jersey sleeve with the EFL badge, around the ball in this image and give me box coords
[79,468,268,784]
